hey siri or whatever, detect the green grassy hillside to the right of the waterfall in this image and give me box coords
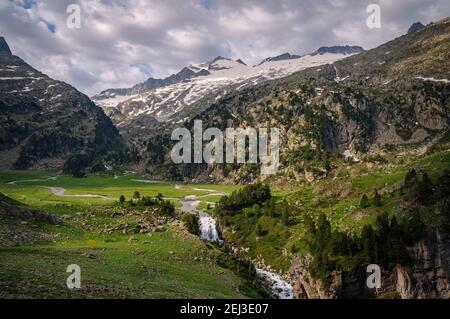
[214,150,450,272]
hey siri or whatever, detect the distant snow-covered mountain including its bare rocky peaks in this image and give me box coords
[93,46,363,125]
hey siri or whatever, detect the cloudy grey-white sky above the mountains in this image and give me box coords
[0,0,450,95]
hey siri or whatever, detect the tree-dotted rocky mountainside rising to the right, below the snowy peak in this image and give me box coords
[147,19,450,182]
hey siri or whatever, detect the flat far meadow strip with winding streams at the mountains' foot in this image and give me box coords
[0,171,240,213]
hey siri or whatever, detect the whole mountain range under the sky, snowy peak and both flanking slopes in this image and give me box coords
[0,19,450,181]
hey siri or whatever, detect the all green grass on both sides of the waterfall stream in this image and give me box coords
[0,150,450,298]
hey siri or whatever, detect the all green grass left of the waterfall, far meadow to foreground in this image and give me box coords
[0,172,260,298]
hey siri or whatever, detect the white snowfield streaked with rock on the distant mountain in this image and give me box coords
[94,53,358,123]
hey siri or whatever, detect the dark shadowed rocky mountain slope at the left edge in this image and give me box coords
[0,38,125,169]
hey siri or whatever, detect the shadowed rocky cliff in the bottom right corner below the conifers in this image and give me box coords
[289,230,450,299]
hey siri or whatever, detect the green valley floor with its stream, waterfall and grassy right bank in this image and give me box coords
[0,141,450,298]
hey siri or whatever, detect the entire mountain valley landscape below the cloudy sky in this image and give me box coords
[0,8,450,299]
